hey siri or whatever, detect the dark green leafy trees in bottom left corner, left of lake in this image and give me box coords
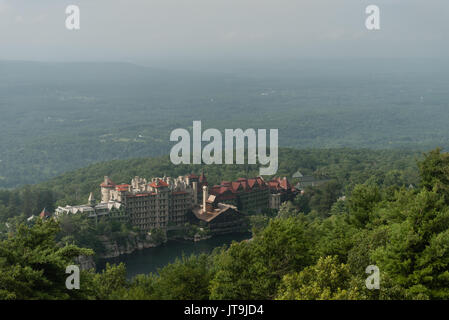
[0,219,93,300]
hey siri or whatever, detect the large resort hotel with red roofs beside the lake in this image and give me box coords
[55,173,296,231]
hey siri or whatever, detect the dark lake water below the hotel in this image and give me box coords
[97,233,251,278]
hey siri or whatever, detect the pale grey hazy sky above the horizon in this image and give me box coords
[0,0,449,69]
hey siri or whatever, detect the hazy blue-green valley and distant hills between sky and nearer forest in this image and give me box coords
[0,61,449,188]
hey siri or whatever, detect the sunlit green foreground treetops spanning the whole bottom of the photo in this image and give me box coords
[0,150,449,300]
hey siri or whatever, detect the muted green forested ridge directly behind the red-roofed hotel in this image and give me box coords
[0,149,422,228]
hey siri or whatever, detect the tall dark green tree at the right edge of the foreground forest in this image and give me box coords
[371,189,449,299]
